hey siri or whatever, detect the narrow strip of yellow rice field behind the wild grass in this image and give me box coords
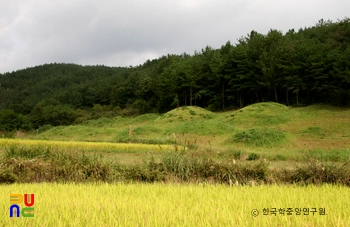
[0,139,174,153]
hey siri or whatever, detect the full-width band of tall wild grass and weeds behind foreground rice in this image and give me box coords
[0,144,350,186]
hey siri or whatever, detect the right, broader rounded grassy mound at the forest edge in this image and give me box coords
[225,102,292,126]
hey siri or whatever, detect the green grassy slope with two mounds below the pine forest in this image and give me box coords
[24,102,350,161]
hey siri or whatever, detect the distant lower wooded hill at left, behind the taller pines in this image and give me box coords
[0,63,125,114]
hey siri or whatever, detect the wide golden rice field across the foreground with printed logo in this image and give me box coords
[0,183,350,227]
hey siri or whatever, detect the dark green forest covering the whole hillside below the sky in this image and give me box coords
[0,18,350,130]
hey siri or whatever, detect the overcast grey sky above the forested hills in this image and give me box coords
[0,0,350,73]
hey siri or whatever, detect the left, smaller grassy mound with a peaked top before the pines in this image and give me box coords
[155,106,216,123]
